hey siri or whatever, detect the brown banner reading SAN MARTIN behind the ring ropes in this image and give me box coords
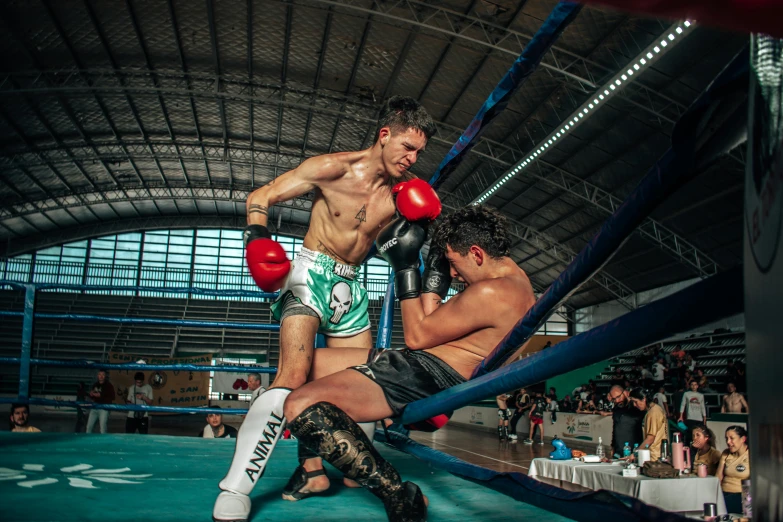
[109,352,212,407]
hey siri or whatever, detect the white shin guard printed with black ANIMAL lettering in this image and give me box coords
[219,388,291,495]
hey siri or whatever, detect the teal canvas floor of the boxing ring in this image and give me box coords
[0,433,567,522]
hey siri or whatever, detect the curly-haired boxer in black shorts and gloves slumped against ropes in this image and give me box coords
[285,206,535,521]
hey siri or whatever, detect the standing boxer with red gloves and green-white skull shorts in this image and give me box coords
[212,97,441,521]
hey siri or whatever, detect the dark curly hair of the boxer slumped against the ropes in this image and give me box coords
[432,205,511,258]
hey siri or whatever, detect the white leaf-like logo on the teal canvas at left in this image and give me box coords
[0,464,152,489]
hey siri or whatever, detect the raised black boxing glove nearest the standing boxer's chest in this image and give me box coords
[375,217,427,301]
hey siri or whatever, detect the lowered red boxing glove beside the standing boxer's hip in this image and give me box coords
[245,225,291,292]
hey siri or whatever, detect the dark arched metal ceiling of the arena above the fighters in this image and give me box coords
[0,0,747,307]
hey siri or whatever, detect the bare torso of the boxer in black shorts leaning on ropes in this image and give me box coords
[425,268,536,379]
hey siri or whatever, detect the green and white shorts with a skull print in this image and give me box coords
[272,247,370,337]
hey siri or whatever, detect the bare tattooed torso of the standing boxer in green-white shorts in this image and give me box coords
[304,153,402,265]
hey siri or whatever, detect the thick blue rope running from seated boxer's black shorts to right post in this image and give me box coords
[401,266,745,424]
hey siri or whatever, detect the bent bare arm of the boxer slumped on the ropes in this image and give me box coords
[400,281,502,350]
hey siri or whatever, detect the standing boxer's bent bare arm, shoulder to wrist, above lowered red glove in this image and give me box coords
[247,154,347,226]
